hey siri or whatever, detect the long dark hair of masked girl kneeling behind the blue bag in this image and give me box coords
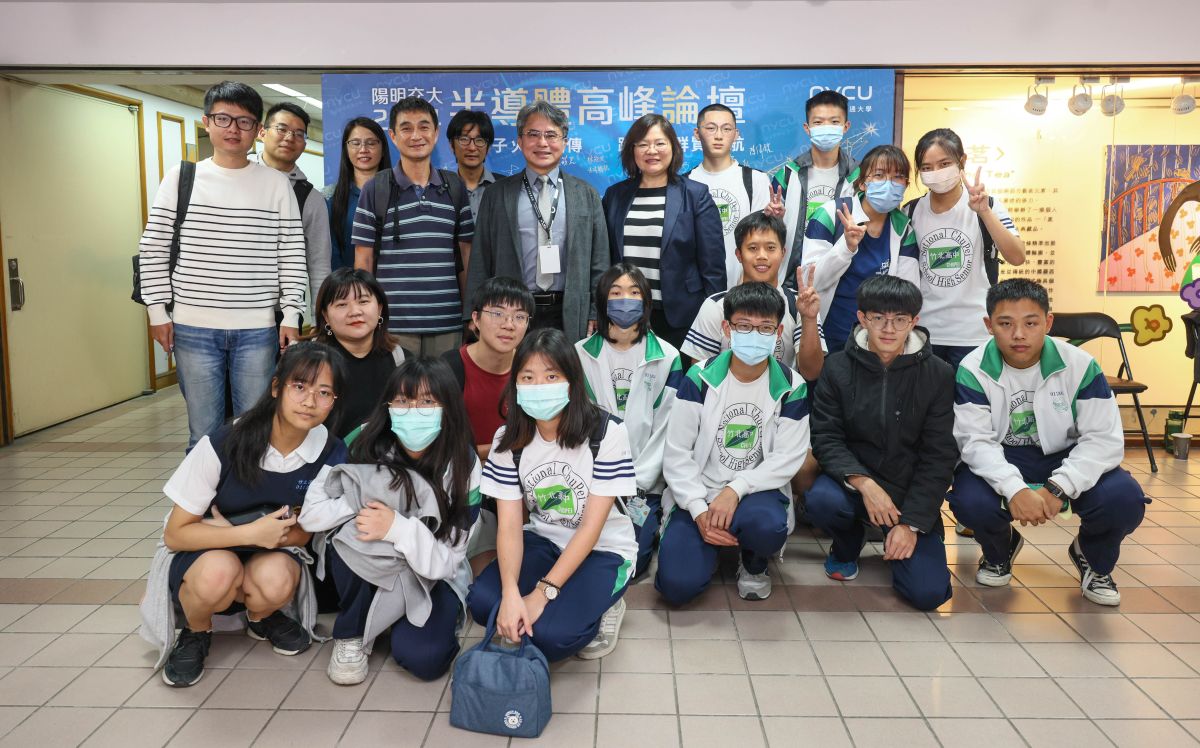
[496,328,601,451]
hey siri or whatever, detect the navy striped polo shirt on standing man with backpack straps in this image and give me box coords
[352,164,475,335]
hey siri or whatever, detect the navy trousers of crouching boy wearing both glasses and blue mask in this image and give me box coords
[654,491,787,605]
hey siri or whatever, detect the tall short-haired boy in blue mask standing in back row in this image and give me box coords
[773,90,858,286]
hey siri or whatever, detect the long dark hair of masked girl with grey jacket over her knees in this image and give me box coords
[350,357,476,543]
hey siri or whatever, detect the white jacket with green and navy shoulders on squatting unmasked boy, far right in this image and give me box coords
[954,337,1124,501]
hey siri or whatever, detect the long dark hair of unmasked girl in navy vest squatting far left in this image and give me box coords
[224,342,346,487]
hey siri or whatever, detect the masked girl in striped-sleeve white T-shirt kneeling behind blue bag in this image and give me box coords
[467,329,637,662]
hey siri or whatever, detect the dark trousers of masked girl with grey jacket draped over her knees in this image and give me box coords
[325,544,462,681]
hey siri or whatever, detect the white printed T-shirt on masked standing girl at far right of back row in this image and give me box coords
[912,190,1020,346]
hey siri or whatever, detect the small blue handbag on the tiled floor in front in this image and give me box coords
[450,603,551,737]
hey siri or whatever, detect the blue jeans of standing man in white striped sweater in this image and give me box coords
[175,324,280,450]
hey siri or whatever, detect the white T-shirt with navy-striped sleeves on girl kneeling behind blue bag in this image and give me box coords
[481,421,637,579]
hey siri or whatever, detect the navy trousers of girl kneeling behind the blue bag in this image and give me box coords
[467,531,631,662]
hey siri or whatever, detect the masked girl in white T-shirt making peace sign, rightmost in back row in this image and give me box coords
[905,128,1025,366]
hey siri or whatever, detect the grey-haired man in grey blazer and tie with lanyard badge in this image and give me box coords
[463,101,611,341]
